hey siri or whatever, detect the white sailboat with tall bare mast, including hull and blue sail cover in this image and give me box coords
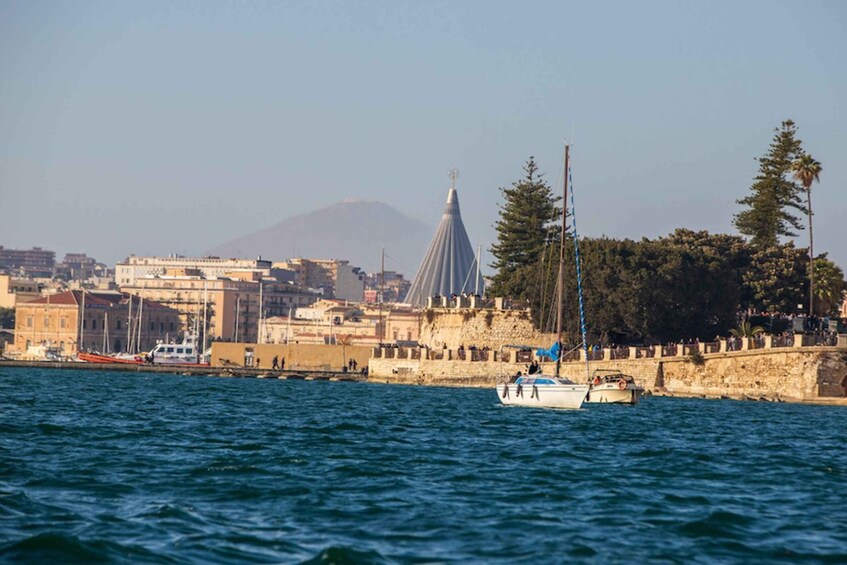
[496,145,589,409]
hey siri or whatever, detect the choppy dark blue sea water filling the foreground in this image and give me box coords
[0,368,847,563]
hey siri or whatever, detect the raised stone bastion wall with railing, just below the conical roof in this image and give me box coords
[420,308,556,350]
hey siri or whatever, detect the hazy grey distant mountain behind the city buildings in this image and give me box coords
[209,199,433,279]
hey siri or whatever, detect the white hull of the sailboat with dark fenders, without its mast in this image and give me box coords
[497,374,588,409]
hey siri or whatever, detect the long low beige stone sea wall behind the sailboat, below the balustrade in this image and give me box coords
[370,346,847,400]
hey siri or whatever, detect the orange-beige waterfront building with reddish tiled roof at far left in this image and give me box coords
[8,290,179,356]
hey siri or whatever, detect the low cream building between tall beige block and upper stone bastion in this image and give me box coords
[264,299,420,346]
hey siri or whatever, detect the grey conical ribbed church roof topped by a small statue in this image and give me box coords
[405,188,482,306]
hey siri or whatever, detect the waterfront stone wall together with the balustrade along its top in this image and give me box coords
[370,334,847,403]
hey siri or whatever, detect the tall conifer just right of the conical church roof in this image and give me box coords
[488,157,562,310]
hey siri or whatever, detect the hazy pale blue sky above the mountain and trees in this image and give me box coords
[0,0,847,276]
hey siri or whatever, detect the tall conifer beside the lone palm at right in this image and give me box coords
[734,120,805,248]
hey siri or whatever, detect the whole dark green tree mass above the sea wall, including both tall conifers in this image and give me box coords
[488,120,847,345]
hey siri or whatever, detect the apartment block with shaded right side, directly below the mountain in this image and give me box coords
[273,258,365,302]
